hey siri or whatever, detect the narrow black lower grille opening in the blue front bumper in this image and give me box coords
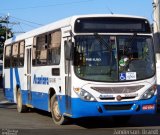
[104,104,133,111]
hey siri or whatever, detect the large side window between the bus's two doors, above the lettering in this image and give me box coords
[32,31,61,66]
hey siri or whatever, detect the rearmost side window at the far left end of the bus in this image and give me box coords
[4,45,11,68]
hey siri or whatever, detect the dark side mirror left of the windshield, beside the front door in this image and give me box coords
[65,41,74,60]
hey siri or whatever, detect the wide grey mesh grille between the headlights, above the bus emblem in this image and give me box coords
[91,85,144,94]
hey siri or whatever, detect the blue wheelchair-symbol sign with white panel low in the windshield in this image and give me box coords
[119,72,137,81]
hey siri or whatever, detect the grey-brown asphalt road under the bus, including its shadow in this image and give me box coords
[0,90,160,135]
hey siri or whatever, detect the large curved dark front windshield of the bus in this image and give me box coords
[74,34,155,82]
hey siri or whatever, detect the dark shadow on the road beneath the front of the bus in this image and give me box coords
[74,113,160,129]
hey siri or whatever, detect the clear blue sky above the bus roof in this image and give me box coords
[0,0,153,33]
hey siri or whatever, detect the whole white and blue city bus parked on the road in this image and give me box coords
[3,14,157,124]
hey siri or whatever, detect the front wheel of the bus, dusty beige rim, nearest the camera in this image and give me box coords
[51,95,67,125]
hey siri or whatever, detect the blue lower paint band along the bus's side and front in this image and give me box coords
[6,89,157,118]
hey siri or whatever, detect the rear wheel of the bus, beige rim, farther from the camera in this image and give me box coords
[17,89,28,113]
